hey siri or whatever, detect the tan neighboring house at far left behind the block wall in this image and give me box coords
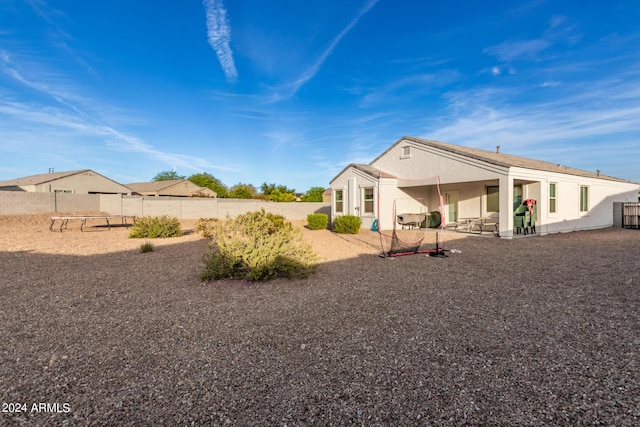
[0,169,131,194]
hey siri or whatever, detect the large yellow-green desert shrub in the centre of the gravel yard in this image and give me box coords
[201,209,317,281]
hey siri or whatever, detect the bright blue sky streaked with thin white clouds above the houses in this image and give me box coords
[0,0,640,192]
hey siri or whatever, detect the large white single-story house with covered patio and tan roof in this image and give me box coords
[331,137,640,238]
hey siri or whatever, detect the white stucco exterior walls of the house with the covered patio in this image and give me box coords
[332,140,638,238]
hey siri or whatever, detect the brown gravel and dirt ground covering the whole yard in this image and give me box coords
[0,215,640,426]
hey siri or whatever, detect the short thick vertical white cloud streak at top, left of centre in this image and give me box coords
[203,0,238,82]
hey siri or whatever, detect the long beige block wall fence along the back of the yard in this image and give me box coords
[0,191,331,221]
